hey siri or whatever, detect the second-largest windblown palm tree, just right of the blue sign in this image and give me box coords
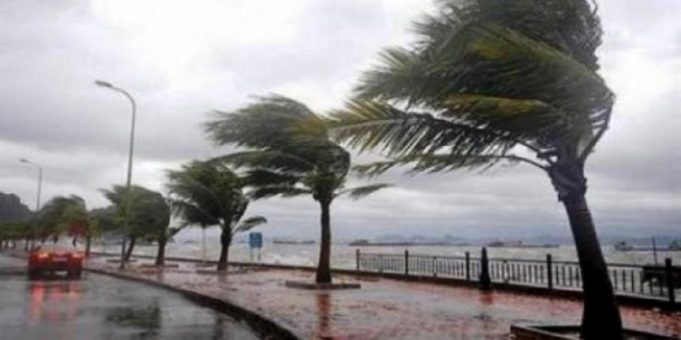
[206,96,386,284]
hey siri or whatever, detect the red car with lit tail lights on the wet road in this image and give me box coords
[28,246,84,280]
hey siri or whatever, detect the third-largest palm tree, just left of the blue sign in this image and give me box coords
[168,161,267,271]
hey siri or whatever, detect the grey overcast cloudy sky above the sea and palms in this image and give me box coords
[0,0,681,238]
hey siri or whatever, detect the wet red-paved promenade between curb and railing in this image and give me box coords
[91,261,681,339]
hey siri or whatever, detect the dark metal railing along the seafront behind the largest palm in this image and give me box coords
[356,249,681,304]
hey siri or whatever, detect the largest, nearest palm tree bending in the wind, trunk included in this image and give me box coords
[335,0,622,339]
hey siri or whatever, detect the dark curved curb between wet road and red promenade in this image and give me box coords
[83,267,300,340]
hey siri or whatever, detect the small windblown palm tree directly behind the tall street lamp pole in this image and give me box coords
[102,185,170,261]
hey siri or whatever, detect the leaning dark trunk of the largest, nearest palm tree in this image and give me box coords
[563,194,622,340]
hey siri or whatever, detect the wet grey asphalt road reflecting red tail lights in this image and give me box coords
[0,255,257,339]
